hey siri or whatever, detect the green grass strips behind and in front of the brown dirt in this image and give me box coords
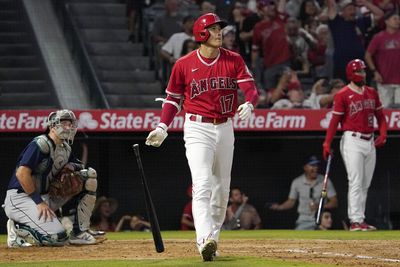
[0,230,400,267]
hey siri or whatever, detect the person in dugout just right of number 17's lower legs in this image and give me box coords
[222,187,262,230]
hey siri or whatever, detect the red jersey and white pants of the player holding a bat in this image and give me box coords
[333,85,382,223]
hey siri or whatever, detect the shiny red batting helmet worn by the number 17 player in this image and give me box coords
[193,13,228,42]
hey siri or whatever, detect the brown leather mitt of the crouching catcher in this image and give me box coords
[49,167,84,198]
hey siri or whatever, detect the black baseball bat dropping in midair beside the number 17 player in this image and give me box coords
[133,144,164,253]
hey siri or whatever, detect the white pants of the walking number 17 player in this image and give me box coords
[184,116,235,250]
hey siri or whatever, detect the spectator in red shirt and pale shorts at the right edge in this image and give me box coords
[365,9,400,108]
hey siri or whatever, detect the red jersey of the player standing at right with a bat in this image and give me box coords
[333,85,383,134]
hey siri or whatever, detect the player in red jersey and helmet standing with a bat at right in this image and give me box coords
[323,59,387,231]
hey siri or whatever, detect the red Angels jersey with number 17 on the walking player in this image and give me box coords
[166,48,254,118]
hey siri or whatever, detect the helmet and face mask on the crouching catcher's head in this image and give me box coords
[47,109,78,144]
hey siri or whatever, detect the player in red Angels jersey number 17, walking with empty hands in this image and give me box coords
[146,13,258,261]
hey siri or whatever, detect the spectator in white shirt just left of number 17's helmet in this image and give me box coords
[160,15,194,65]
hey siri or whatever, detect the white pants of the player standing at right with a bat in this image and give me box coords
[340,131,376,223]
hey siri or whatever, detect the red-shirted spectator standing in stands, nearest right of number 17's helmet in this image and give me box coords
[251,0,291,90]
